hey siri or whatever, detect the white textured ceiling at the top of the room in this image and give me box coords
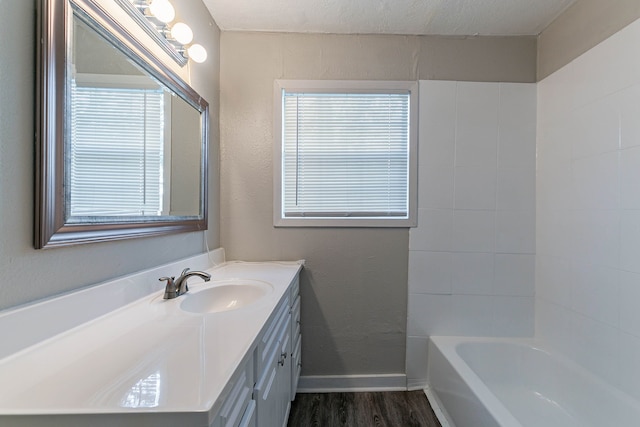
[203,0,577,36]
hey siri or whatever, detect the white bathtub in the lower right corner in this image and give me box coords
[427,337,640,427]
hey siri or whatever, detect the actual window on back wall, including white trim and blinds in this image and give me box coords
[274,80,418,227]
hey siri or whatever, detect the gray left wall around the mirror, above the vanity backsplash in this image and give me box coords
[0,0,220,314]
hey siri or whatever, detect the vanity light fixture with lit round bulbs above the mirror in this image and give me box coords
[127,0,207,65]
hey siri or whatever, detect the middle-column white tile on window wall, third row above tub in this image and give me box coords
[453,210,495,252]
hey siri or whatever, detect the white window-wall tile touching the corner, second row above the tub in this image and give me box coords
[492,254,535,297]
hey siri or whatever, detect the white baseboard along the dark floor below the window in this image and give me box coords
[297,374,407,393]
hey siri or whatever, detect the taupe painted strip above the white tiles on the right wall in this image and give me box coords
[538,0,640,80]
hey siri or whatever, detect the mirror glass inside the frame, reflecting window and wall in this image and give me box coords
[65,15,201,222]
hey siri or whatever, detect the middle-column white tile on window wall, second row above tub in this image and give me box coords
[451,252,494,295]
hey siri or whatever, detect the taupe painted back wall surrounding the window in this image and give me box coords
[220,32,536,375]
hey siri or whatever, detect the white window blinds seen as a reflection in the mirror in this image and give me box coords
[67,85,164,216]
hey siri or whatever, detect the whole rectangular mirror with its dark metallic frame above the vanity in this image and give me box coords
[35,0,209,248]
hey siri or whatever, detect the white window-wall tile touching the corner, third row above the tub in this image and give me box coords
[496,211,536,254]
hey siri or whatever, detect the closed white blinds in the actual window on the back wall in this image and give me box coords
[282,91,409,218]
